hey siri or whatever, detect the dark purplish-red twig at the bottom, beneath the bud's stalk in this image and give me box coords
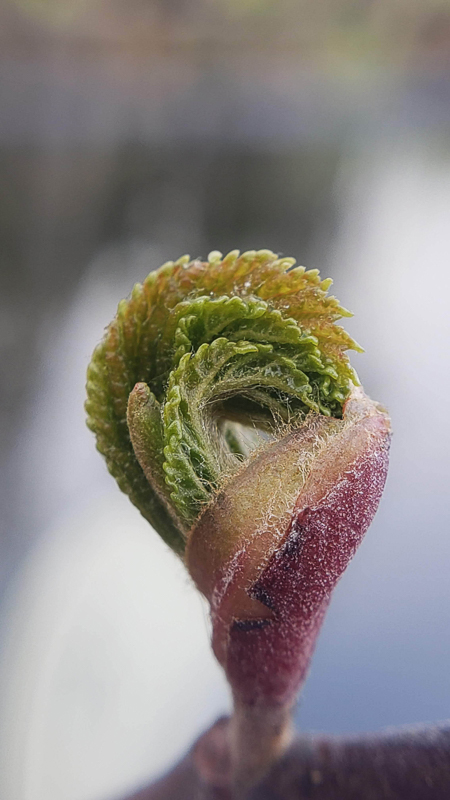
[128,719,450,800]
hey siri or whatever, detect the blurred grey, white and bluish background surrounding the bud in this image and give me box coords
[0,0,450,800]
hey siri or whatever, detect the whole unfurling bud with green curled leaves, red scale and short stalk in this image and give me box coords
[86,250,390,783]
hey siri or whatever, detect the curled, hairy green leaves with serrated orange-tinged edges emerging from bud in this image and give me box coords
[86,250,359,553]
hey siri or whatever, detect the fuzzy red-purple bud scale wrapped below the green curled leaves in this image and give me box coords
[187,390,390,704]
